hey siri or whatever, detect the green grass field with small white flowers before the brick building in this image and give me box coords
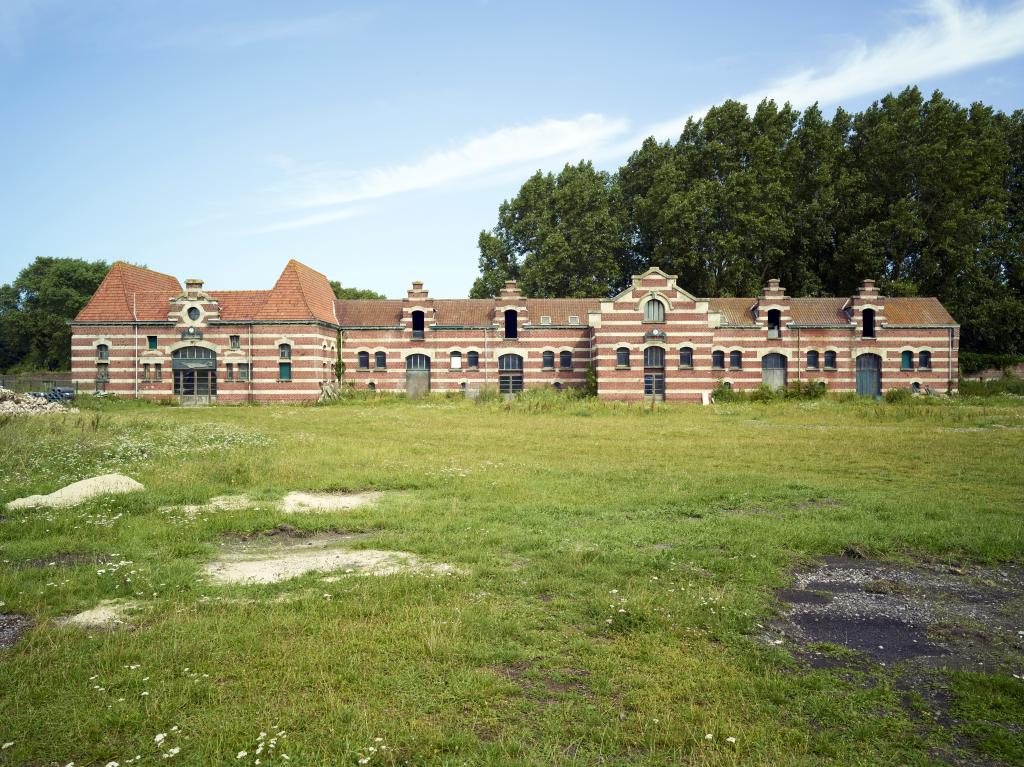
[0,397,1024,766]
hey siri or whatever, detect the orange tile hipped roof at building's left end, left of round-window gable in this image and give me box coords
[75,261,181,323]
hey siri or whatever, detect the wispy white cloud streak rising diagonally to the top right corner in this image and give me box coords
[258,0,1024,231]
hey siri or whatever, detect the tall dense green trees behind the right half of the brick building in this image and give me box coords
[472,88,1024,353]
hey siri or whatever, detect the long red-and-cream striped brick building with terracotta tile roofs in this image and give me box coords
[72,261,959,402]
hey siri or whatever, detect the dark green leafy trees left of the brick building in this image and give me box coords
[0,258,111,372]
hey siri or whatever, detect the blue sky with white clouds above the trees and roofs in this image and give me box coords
[0,0,1024,297]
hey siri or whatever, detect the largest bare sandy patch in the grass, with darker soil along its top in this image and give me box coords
[204,525,457,584]
